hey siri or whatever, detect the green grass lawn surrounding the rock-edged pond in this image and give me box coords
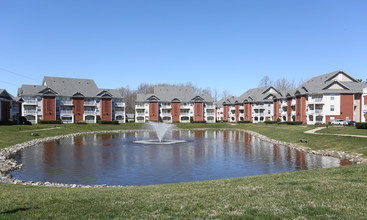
[0,123,367,219]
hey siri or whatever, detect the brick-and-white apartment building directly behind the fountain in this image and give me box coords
[135,86,215,123]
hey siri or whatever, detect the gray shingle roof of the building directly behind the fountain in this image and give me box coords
[136,86,213,102]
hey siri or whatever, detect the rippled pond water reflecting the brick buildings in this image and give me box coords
[11,130,345,186]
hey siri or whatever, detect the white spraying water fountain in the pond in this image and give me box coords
[134,121,186,144]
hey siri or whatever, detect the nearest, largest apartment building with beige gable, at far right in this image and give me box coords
[274,70,367,124]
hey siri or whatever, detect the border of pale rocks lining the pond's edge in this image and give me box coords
[0,128,367,188]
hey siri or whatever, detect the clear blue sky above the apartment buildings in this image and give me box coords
[0,0,367,95]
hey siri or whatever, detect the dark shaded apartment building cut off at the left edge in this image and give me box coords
[0,89,21,121]
